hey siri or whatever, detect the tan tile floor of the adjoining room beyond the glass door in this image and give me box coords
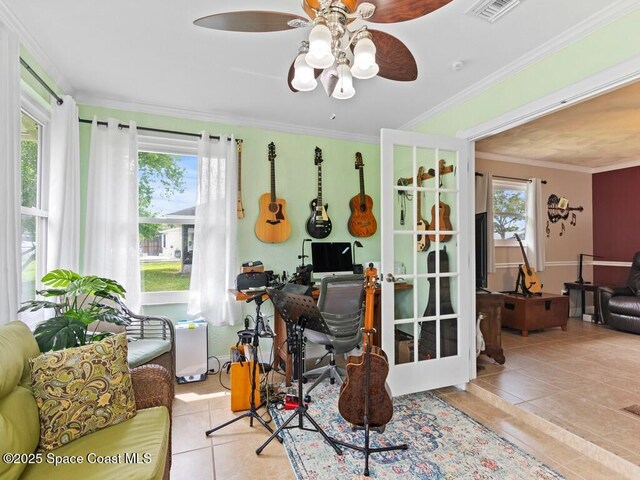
[472,318,640,465]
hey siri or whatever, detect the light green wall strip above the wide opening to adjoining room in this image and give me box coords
[415,8,640,135]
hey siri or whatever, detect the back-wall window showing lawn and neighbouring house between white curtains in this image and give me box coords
[138,150,198,304]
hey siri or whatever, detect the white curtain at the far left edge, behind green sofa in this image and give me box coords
[0,24,22,324]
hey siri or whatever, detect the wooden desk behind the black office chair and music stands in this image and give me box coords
[229,283,413,386]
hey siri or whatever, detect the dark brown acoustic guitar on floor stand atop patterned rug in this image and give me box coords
[332,265,409,476]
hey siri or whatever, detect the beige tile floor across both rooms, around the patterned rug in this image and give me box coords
[171,320,640,480]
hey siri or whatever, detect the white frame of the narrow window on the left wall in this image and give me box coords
[18,90,51,328]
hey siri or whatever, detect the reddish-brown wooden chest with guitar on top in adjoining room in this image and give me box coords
[502,293,569,337]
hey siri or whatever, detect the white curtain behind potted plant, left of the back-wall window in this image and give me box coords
[83,118,140,311]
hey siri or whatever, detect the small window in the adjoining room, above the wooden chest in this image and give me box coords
[493,180,527,246]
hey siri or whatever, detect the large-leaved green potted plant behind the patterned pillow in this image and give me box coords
[18,269,130,352]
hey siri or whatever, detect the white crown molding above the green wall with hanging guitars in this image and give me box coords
[75,95,380,145]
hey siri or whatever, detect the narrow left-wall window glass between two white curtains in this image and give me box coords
[20,110,47,302]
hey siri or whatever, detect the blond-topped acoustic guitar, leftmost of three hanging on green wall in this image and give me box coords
[255,142,291,243]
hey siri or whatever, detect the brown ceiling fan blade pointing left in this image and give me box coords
[193,10,307,32]
